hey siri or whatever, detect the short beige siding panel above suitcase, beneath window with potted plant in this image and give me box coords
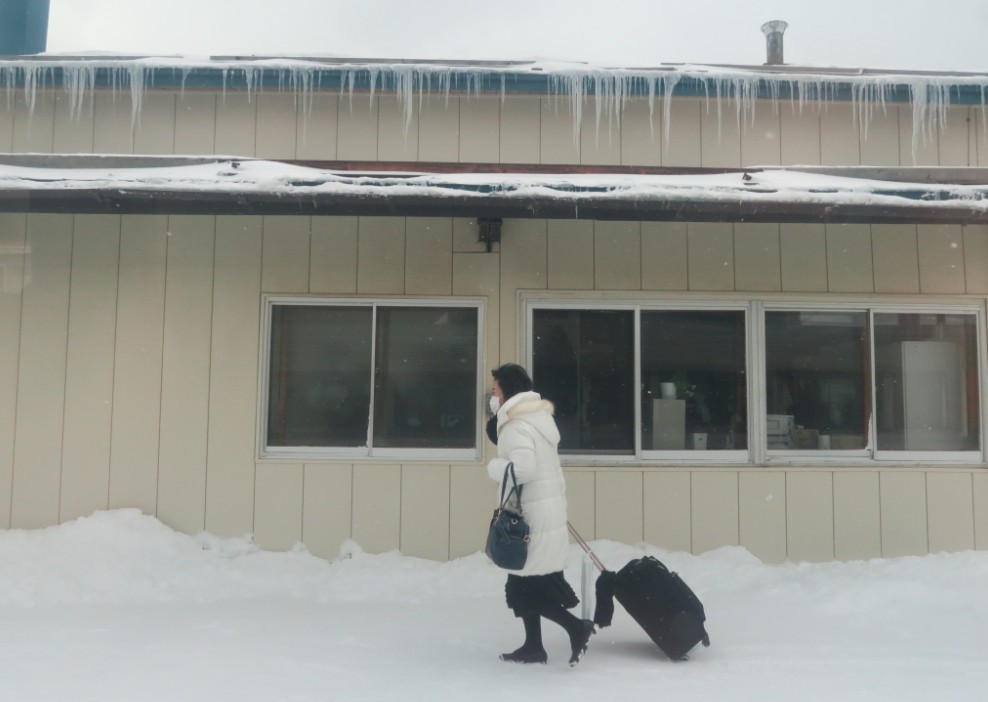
[642,471,691,553]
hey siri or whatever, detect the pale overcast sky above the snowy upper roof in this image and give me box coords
[48,0,988,71]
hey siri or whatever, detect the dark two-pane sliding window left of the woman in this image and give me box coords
[265,299,480,458]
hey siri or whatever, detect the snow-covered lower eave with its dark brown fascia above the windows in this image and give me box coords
[0,155,988,223]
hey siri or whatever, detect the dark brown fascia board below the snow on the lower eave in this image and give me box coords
[0,188,988,224]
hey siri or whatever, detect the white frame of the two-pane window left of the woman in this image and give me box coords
[257,295,487,462]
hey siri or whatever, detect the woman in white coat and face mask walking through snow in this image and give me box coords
[487,363,594,665]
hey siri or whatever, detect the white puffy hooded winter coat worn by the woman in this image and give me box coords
[487,392,569,575]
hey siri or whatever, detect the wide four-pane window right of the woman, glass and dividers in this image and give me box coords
[528,300,984,464]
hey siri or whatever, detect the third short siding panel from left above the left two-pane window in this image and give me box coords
[357,217,405,295]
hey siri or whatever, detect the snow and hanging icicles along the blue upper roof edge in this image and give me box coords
[0,54,988,162]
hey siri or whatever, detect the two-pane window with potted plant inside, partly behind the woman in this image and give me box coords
[531,308,748,457]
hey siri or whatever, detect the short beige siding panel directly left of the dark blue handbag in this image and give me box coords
[449,465,497,558]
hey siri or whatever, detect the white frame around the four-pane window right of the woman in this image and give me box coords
[521,295,988,467]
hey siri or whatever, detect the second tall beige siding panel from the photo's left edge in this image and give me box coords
[10,215,72,529]
